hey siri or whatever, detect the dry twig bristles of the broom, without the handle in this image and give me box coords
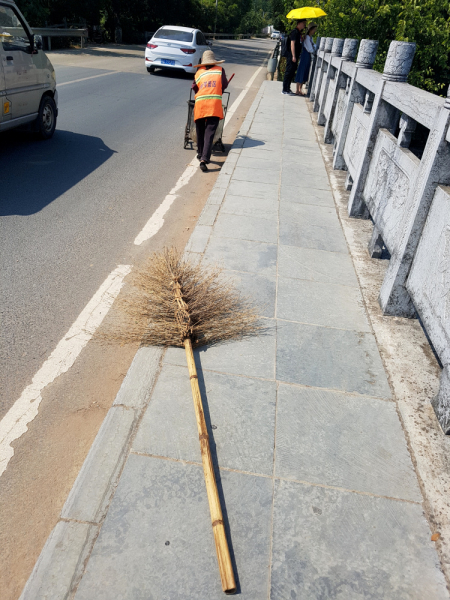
[101,248,263,347]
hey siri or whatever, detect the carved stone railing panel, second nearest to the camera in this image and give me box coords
[363,129,420,254]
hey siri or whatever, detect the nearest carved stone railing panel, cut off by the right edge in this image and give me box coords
[406,186,450,366]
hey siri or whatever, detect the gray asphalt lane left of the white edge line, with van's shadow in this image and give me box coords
[0,40,273,419]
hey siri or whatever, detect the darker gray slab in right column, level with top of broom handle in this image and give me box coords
[277,321,391,398]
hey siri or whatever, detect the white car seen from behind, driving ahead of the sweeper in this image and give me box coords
[145,25,212,73]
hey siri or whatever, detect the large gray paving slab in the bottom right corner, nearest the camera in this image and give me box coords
[270,481,448,600]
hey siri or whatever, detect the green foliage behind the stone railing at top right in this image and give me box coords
[284,0,450,94]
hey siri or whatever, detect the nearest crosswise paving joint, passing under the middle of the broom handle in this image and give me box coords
[130,449,423,506]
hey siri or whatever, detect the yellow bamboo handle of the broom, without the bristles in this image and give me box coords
[184,339,236,594]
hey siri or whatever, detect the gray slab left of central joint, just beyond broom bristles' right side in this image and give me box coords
[204,236,277,275]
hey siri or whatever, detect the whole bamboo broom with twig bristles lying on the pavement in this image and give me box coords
[104,248,262,594]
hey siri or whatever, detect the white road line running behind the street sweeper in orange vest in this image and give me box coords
[134,60,265,246]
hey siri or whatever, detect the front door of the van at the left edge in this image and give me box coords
[0,3,42,119]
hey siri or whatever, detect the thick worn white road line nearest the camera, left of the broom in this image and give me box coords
[0,265,131,476]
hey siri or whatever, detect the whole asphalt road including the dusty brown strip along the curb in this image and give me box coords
[0,40,274,600]
